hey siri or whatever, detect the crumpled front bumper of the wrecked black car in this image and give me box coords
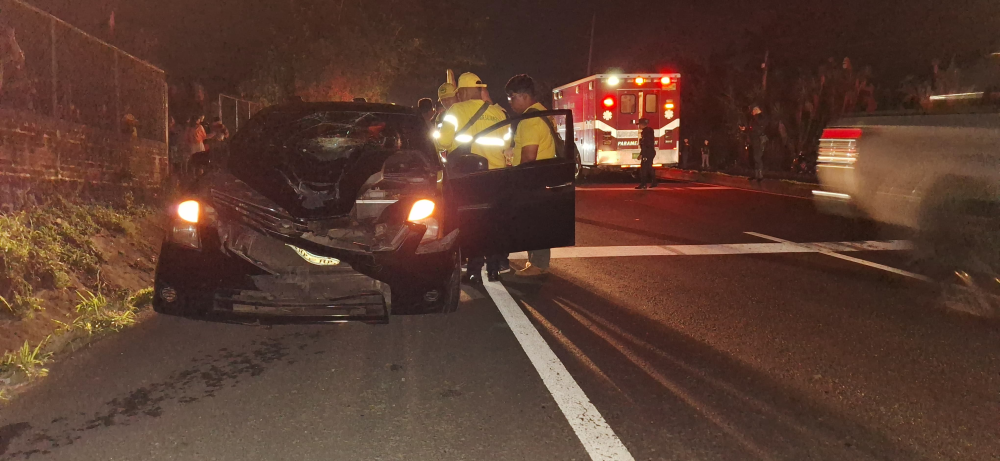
[154,214,454,323]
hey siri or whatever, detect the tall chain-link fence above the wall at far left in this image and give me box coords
[0,0,167,143]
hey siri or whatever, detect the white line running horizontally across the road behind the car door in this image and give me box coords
[510,241,913,259]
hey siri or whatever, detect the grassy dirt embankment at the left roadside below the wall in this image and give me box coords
[0,199,164,400]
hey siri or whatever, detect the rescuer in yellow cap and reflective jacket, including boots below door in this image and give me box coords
[434,72,507,284]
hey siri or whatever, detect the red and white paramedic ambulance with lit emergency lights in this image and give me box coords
[552,74,681,175]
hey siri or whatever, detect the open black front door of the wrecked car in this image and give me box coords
[445,110,576,257]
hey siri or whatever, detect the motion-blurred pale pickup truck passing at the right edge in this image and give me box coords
[814,107,1000,291]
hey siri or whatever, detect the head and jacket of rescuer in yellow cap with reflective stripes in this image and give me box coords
[433,72,509,170]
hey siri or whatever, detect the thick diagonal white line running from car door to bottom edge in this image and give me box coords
[484,276,634,461]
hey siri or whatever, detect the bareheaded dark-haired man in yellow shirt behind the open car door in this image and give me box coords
[504,74,556,277]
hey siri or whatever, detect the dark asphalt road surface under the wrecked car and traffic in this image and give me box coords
[0,178,1000,461]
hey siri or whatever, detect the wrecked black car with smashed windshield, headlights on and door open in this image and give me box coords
[153,102,575,322]
